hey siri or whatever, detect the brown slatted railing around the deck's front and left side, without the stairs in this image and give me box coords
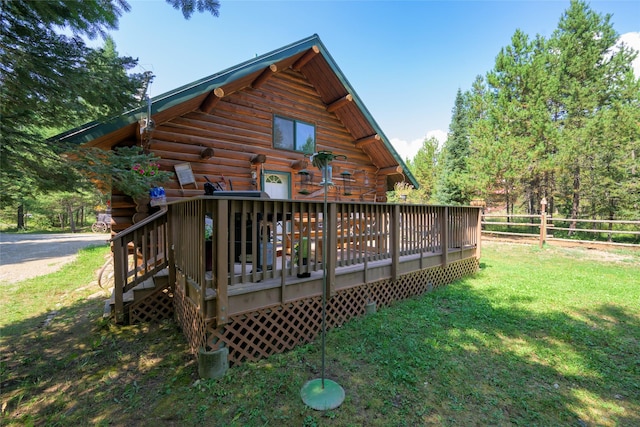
[168,196,480,324]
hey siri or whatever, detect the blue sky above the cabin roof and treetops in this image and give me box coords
[107,0,640,158]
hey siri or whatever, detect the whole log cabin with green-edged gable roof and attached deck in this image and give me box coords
[59,35,480,374]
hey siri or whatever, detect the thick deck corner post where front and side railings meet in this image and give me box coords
[216,199,229,326]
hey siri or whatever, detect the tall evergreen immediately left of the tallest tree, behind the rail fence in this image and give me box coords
[475,30,555,213]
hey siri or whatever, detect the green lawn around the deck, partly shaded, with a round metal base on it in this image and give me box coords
[0,243,640,426]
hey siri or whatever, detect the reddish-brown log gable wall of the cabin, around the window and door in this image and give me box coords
[112,69,388,230]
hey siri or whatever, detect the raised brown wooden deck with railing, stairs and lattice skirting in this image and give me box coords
[113,197,480,363]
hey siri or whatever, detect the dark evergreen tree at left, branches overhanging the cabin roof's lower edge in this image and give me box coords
[0,0,219,221]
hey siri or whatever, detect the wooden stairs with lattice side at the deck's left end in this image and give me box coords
[103,268,173,324]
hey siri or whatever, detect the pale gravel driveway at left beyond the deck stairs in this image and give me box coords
[0,233,111,284]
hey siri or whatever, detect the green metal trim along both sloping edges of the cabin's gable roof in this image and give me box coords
[50,34,419,188]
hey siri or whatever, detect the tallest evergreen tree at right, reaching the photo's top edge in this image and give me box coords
[550,0,635,228]
